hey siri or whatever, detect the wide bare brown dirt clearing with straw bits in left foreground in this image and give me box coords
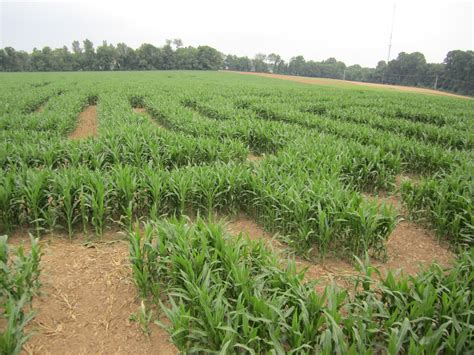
[7,233,178,354]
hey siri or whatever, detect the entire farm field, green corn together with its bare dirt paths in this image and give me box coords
[0,71,474,354]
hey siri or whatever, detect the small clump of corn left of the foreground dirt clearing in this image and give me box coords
[0,236,41,354]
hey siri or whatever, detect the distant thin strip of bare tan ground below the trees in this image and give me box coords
[223,70,472,99]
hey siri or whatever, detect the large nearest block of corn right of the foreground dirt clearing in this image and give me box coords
[130,218,474,354]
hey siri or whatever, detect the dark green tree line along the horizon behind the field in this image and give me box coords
[0,39,474,95]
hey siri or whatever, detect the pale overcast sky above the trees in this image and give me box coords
[0,0,474,66]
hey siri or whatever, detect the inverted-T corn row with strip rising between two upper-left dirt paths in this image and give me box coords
[0,96,248,169]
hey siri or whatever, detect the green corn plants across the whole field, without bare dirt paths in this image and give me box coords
[0,72,474,354]
